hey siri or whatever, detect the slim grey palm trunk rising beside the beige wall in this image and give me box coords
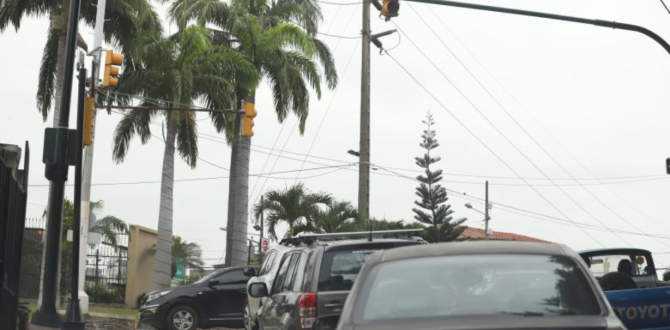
[152,112,177,290]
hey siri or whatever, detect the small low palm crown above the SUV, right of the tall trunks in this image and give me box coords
[254,183,333,240]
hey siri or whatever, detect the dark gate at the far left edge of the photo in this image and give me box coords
[0,143,30,329]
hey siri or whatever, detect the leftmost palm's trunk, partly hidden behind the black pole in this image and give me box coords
[37,0,70,308]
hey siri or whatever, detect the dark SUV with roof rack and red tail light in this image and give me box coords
[247,230,425,330]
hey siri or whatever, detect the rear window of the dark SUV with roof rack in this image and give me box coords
[318,249,375,292]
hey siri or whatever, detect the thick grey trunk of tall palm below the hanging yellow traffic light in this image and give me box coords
[225,94,255,267]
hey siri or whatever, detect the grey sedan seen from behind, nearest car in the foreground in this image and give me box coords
[334,241,624,330]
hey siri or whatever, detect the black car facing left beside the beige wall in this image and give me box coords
[137,267,256,330]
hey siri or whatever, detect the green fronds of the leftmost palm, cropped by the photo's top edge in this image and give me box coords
[0,0,161,123]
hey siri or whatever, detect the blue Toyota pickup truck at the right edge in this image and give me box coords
[580,248,670,329]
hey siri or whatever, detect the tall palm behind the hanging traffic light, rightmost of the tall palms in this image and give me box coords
[170,0,338,266]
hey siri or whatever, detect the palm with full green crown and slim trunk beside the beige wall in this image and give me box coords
[113,27,259,290]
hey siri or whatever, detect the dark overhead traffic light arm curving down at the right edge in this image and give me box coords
[405,0,670,53]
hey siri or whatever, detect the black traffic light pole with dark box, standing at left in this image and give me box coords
[32,0,81,327]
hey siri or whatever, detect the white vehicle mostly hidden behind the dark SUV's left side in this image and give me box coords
[244,244,289,330]
